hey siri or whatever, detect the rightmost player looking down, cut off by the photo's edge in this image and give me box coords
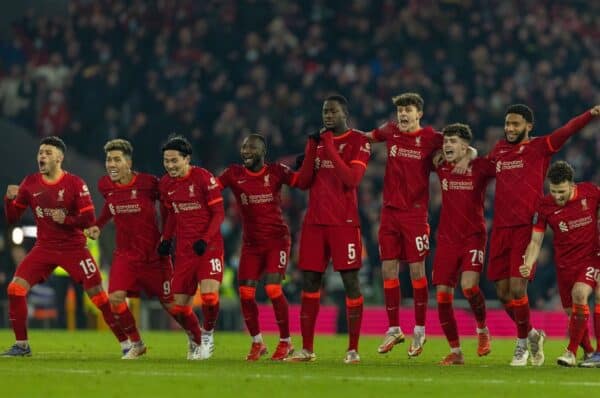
[519,161,600,366]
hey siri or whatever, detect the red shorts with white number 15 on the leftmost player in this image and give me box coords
[15,246,102,290]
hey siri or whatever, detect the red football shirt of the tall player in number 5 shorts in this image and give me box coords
[304,130,371,226]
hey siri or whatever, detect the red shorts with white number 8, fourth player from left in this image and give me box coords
[238,240,290,281]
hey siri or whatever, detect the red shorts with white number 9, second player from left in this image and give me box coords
[108,253,173,303]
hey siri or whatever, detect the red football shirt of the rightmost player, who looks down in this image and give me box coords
[533,182,600,268]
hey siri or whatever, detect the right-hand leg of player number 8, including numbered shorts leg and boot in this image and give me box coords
[265,252,294,361]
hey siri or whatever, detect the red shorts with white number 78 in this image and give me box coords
[432,235,486,287]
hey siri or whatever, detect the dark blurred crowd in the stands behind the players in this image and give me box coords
[0,0,600,308]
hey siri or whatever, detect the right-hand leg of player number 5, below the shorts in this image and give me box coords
[340,269,364,363]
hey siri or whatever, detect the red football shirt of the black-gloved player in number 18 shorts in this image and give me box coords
[159,166,223,253]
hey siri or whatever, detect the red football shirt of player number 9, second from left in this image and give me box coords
[96,173,160,262]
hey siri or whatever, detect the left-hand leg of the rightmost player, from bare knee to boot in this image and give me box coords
[556,282,593,366]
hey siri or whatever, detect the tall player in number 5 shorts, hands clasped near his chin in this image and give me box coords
[286,95,371,363]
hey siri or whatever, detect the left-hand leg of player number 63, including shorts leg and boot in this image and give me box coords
[377,207,404,354]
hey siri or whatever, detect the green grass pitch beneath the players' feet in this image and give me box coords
[0,330,600,398]
